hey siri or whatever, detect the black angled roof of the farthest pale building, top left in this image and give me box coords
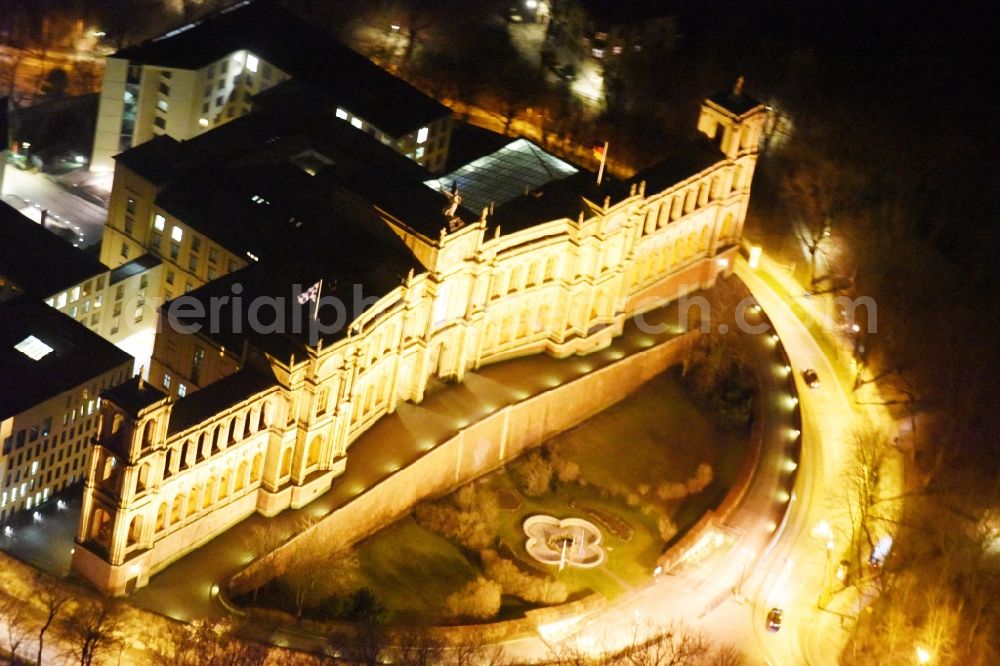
[114,0,451,137]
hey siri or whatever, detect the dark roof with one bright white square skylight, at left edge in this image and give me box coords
[0,295,132,419]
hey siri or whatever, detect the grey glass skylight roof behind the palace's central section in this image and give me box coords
[424,139,577,214]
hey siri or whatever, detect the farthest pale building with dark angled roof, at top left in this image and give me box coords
[91,0,451,171]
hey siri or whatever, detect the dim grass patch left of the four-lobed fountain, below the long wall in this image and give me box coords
[355,516,478,621]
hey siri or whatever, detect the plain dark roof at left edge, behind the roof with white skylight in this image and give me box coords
[0,202,107,298]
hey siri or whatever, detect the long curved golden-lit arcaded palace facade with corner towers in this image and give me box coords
[73,89,763,594]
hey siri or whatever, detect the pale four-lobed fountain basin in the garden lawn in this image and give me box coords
[524,515,607,571]
